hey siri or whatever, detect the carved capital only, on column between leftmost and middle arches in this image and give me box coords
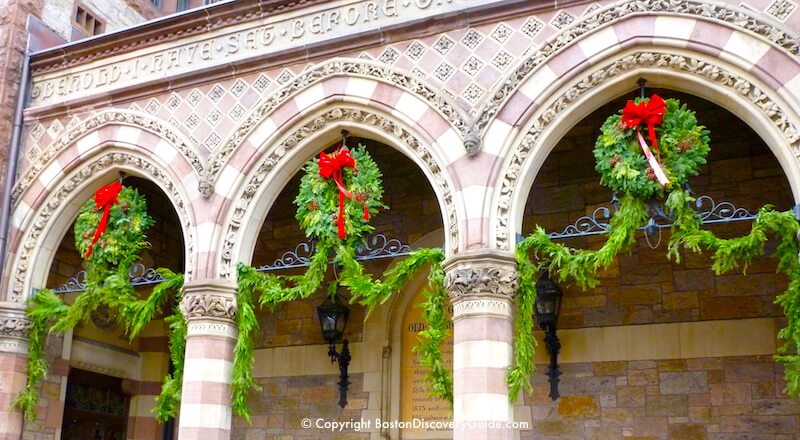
[180,279,237,321]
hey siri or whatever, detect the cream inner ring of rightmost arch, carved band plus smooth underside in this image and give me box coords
[494,48,800,249]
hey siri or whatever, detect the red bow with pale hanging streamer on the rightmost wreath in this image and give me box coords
[622,95,669,186]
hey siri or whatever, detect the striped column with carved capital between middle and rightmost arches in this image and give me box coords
[445,250,517,440]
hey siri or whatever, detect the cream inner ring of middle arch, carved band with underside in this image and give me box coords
[217,103,463,278]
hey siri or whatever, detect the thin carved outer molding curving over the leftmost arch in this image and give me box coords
[11,109,205,206]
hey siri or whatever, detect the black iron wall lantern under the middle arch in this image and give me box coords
[317,290,350,408]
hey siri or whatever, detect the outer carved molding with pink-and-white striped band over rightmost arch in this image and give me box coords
[475,0,800,139]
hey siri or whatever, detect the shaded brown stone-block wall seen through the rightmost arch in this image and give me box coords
[522,90,798,438]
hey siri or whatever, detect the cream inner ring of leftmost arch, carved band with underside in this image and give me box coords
[5,147,197,302]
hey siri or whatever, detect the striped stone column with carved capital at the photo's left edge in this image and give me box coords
[0,302,31,440]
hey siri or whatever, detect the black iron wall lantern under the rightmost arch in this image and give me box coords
[535,270,563,400]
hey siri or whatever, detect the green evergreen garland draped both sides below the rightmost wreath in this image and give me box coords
[508,190,800,399]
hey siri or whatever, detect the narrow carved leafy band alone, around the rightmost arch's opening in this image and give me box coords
[495,51,800,249]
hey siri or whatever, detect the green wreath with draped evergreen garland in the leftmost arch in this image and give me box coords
[12,188,186,421]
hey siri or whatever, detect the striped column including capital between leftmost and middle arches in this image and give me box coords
[178,280,237,440]
